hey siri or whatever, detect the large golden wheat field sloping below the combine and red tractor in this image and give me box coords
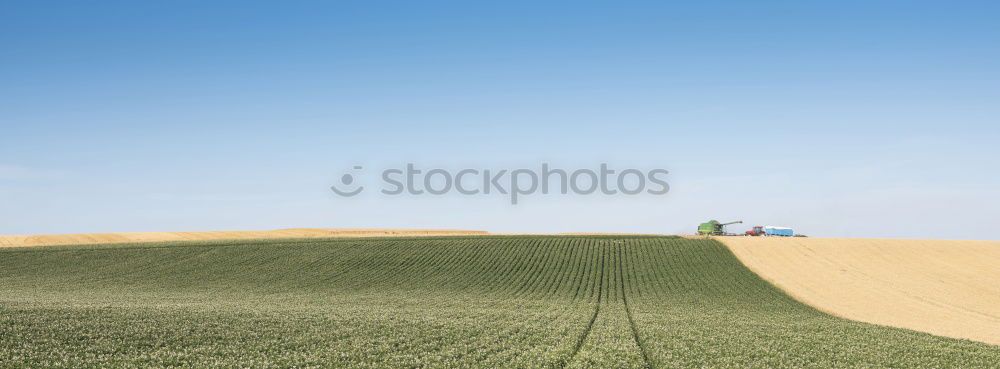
[717,237,1000,345]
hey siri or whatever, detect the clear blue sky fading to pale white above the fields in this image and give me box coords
[0,1,1000,239]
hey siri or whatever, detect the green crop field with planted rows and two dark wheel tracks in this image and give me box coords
[0,236,1000,368]
